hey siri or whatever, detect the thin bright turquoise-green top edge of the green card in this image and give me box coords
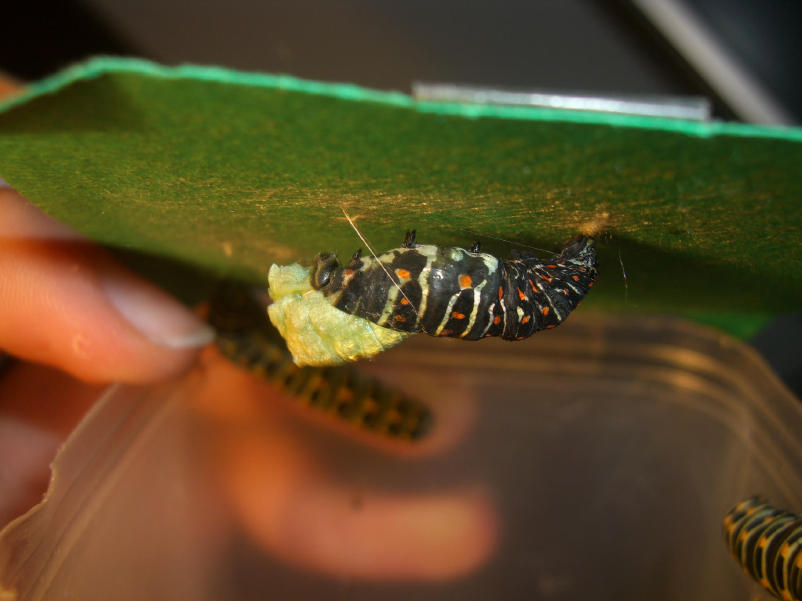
[0,56,802,142]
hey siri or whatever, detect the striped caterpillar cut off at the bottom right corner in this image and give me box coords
[723,497,802,601]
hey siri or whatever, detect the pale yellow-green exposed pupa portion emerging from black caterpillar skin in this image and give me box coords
[267,263,411,365]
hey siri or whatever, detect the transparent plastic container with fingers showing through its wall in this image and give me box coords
[0,313,802,601]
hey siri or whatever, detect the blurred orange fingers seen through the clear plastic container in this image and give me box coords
[190,348,499,582]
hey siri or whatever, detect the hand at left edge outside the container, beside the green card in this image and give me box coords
[0,186,213,527]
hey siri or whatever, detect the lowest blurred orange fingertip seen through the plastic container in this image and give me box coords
[230,466,498,582]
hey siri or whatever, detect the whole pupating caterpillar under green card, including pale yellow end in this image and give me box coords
[268,231,598,365]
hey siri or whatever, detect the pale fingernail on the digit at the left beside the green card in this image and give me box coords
[102,273,214,349]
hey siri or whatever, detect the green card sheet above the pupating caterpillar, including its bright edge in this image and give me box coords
[0,58,802,336]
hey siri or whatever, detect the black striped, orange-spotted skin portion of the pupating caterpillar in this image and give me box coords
[311,230,598,340]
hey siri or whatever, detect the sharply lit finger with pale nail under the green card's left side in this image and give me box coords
[0,188,214,382]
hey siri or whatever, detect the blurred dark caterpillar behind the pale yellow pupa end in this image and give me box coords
[208,282,433,441]
